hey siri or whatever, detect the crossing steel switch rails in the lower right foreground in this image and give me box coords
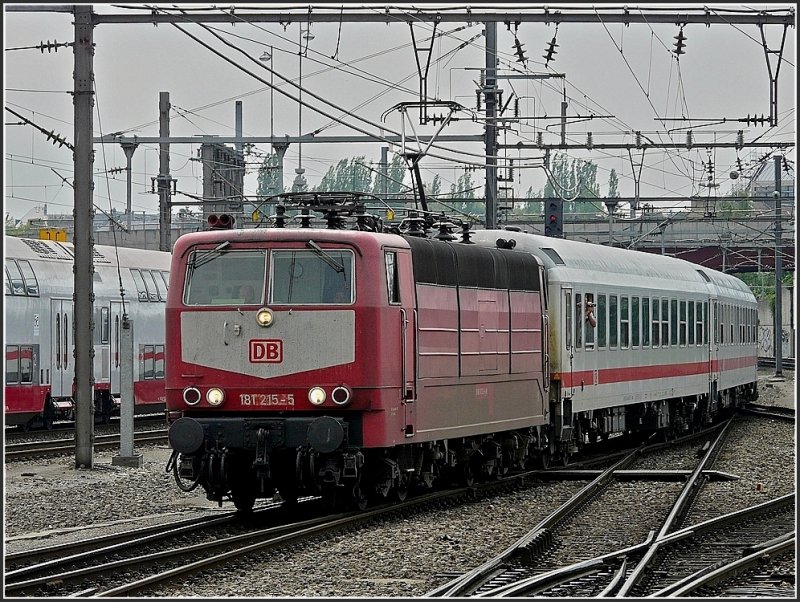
[427,421,794,597]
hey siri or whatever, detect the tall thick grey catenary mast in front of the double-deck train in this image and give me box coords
[72,4,94,469]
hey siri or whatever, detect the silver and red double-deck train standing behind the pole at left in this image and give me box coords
[3,236,170,429]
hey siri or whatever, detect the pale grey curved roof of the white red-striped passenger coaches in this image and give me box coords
[472,230,753,300]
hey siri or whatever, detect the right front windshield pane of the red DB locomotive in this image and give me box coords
[269,249,354,305]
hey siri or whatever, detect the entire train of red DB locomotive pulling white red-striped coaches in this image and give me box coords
[166,197,757,509]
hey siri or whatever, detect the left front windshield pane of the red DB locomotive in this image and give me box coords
[183,249,266,305]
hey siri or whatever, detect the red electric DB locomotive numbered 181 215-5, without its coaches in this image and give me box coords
[166,195,548,509]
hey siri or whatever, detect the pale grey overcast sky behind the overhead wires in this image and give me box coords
[4,3,797,218]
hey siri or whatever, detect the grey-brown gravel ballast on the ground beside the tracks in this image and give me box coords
[4,372,796,597]
